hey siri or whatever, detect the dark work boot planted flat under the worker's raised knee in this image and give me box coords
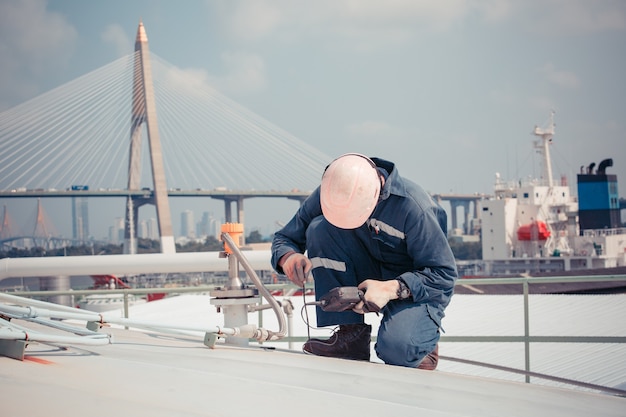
[302,324,372,361]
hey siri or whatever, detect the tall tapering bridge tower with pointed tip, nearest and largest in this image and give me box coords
[124,22,176,254]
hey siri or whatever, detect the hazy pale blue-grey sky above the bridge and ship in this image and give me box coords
[0,0,626,237]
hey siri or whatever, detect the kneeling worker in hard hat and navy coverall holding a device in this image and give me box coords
[272,154,457,369]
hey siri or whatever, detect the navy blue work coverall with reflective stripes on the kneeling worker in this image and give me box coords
[272,158,457,367]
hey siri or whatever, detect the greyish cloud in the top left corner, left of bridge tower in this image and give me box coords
[0,0,77,109]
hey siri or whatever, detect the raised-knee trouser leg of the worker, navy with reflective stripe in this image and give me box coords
[306,216,380,326]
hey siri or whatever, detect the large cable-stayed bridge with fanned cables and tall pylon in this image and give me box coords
[0,23,498,253]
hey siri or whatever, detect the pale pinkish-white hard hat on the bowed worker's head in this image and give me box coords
[320,153,380,229]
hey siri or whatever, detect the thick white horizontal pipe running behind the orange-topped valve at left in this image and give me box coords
[0,250,272,280]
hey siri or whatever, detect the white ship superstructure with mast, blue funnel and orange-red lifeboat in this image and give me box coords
[481,113,626,275]
